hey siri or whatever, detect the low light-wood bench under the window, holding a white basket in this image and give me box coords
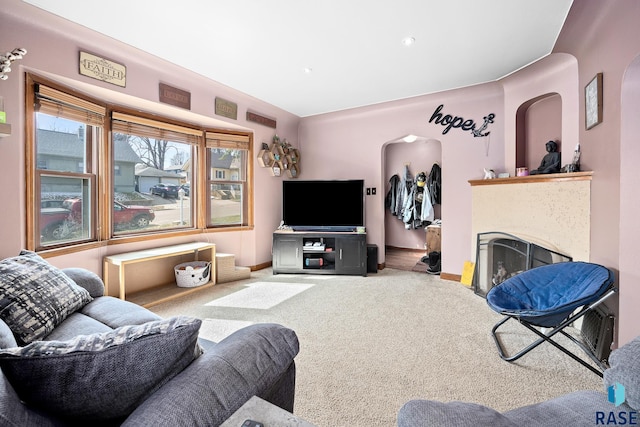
[103,242,216,307]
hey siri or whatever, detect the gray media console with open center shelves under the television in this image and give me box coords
[272,231,367,276]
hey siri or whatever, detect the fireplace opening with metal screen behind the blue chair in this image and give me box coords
[472,231,572,297]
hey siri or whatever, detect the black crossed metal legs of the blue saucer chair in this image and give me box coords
[491,289,616,377]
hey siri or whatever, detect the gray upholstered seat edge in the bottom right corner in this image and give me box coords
[398,337,640,427]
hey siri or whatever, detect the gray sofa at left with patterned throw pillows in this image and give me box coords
[0,251,299,427]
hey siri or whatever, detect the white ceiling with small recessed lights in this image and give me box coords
[24,0,573,117]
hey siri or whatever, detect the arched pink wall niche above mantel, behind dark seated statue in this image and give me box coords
[515,92,560,170]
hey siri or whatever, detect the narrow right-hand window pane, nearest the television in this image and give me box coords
[206,132,251,227]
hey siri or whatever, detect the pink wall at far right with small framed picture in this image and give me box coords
[554,0,640,345]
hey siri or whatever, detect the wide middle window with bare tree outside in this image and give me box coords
[111,112,202,235]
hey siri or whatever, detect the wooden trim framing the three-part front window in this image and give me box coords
[25,73,254,256]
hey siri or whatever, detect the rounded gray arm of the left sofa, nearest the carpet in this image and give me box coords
[123,323,300,427]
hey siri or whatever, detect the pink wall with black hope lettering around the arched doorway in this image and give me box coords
[298,83,508,274]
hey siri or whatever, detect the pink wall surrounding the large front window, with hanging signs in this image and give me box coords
[0,0,305,273]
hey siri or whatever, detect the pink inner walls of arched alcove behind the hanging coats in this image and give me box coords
[382,135,442,250]
